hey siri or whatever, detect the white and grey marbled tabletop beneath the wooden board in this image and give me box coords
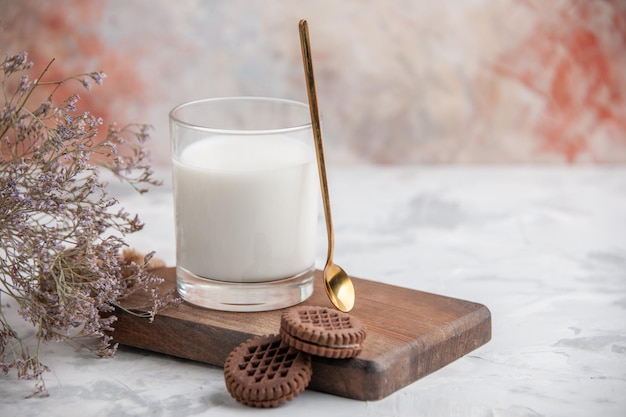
[0,166,626,417]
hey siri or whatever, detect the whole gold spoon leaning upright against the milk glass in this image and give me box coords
[299,19,355,312]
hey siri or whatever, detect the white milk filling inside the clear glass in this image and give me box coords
[173,135,317,282]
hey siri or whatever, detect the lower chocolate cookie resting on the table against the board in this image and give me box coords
[224,335,312,408]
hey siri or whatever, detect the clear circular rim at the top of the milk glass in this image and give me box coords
[169,96,312,135]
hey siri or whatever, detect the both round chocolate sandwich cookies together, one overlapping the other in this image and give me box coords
[224,306,366,408]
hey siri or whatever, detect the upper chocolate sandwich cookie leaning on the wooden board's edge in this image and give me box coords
[280,306,366,359]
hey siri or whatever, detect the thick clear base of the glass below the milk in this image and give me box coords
[176,267,314,312]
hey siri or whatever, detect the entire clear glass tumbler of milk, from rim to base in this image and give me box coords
[170,97,319,311]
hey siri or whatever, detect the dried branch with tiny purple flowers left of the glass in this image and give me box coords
[0,53,180,395]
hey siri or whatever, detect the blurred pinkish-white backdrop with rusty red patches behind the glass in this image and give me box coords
[0,0,626,165]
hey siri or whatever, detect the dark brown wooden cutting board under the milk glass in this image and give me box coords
[113,268,491,400]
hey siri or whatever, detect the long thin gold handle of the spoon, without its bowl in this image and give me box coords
[298,19,335,265]
